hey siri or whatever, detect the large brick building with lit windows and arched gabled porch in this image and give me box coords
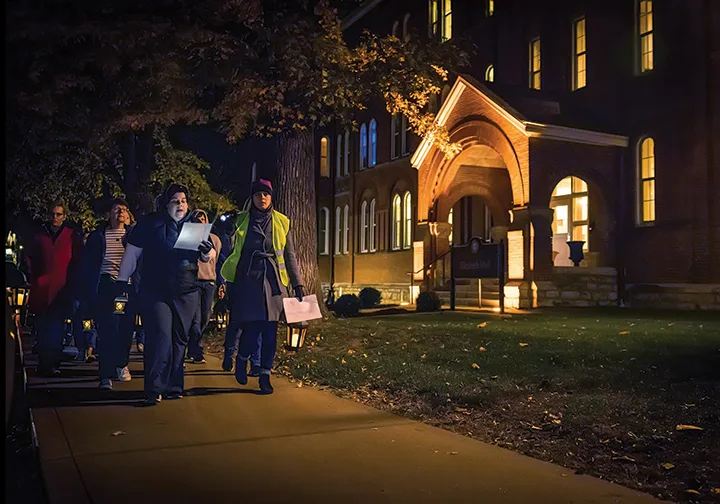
[316,0,720,308]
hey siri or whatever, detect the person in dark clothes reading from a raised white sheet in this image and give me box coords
[117,183,215,406]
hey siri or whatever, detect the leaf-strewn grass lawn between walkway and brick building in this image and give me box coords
[205,309,720,502]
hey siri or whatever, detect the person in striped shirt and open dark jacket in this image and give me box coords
[82,198,137,390]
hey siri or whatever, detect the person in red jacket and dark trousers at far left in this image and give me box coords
[26,202,83,377]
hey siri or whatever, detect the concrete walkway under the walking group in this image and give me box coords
[28,344,660,504]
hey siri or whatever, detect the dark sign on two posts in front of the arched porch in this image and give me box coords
[450,236,505,313]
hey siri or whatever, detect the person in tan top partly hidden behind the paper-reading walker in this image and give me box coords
[188,208,222,364]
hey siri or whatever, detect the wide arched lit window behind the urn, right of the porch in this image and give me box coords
[550,177,590,252]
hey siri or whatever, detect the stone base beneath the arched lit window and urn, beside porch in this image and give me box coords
[535,266,618,307]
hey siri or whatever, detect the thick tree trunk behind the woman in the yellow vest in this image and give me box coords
[274,131,326,315]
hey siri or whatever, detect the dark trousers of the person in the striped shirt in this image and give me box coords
[94,275,137,378]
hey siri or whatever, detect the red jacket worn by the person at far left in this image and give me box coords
[27,225,83,314]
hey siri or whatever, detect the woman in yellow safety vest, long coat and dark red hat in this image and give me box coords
[220,179,303,394]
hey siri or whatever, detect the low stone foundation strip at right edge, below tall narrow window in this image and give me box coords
[627,284,720,310]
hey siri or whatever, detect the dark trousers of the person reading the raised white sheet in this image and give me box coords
[140,291,200,398]
